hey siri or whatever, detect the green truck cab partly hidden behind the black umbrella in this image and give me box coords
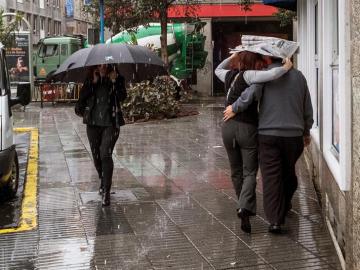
[33,36,84,82]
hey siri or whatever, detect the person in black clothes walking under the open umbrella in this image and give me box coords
[75,65,127,206]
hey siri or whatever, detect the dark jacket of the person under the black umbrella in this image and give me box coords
[75,75,127,128]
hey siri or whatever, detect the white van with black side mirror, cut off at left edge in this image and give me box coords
[0,43,31,198]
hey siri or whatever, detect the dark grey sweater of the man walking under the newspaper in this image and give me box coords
[232,64,314,137]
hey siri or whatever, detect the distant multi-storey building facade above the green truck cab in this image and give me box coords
[5,0,65,44]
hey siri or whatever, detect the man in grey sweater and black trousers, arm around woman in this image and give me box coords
[224,58,314,233]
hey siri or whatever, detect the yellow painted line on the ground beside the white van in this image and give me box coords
[0,128,39,234]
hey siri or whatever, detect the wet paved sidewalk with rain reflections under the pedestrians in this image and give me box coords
[0,104,341,270]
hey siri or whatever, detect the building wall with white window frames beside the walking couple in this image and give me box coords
[297,0,360,270]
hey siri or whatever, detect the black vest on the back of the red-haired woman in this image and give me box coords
[225,70,258,126]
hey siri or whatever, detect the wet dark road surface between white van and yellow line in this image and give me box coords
[0,133,30,229]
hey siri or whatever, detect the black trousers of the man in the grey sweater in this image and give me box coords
[258,135,304,224]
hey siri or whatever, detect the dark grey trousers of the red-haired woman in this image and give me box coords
[222,119,258,214]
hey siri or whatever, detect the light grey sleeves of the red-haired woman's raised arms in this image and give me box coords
[215,57,287,85]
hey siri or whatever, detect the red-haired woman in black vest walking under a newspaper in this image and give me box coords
[215,51,292,233]
